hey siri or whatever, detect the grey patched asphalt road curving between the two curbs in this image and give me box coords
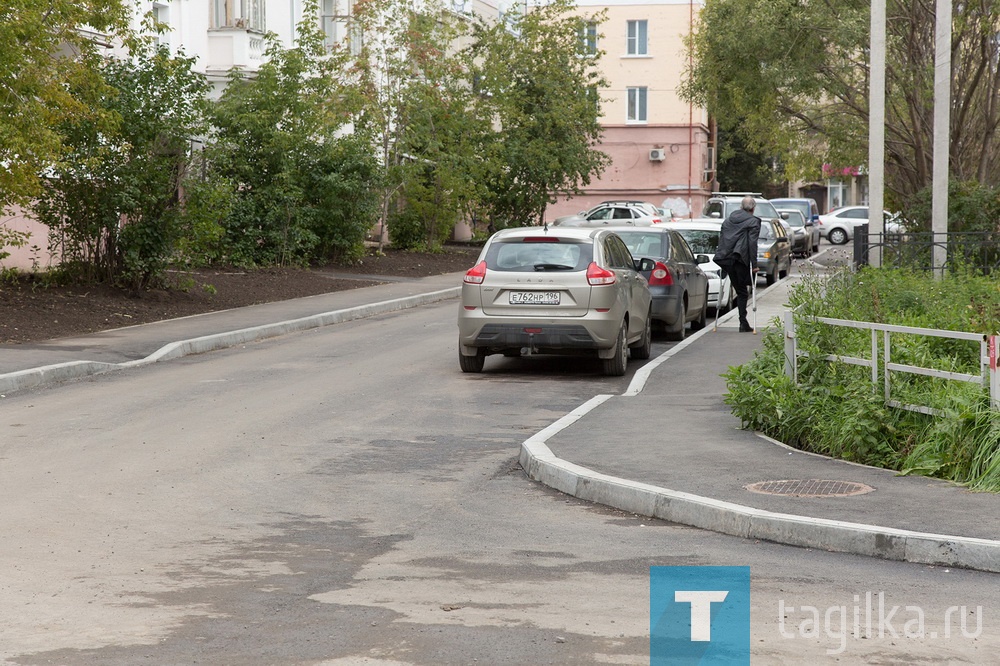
[0,246,1000,665]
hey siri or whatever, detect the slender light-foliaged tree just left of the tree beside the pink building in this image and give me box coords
[353,0,475,249]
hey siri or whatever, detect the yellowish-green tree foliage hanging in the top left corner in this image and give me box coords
[0,0,133,210]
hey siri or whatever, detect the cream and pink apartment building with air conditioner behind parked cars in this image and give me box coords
[545,0,713,221]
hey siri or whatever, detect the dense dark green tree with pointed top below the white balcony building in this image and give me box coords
[208,3,378,265]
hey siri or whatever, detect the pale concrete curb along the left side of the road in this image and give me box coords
[0,287,461,394]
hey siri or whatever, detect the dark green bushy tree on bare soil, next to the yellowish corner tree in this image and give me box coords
[34,41,208,289]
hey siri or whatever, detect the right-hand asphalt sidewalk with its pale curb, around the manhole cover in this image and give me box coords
[521,280,1000,571]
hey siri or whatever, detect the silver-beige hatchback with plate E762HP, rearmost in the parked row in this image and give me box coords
[458,226,653,376]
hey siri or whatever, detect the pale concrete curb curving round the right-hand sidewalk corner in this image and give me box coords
[519,276,1000,572]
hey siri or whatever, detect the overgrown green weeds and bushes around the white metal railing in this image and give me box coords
[725,268,1000,492]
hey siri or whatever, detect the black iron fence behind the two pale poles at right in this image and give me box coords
[854,224,1000,275]
